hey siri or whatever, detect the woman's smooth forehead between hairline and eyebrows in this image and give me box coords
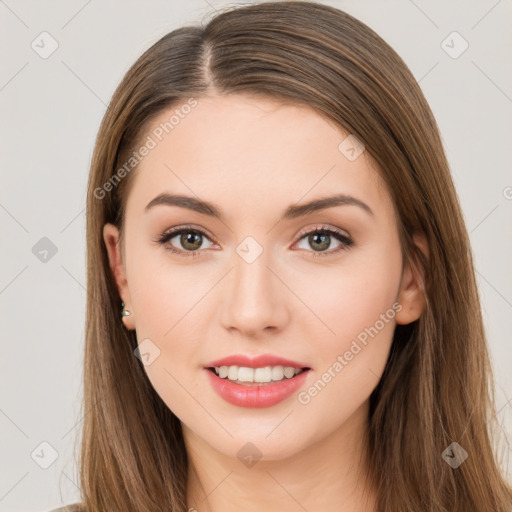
[123,94,389,222]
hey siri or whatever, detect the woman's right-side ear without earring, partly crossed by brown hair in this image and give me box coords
[396,232,428,325]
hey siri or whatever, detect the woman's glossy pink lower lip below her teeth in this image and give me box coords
[205,369,309,408]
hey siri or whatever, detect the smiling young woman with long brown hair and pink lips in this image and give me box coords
[51,2,512,512]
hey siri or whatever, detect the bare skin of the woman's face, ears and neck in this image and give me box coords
[103,95,427,512]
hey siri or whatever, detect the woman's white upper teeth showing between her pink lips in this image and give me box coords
[207,366,311,386]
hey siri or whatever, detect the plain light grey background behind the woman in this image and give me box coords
[0,0,512,512]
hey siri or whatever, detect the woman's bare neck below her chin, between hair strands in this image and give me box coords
[182,402,376,512]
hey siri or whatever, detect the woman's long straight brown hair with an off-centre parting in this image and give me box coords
[75,1,512,512]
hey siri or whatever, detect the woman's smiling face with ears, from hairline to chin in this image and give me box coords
[104,95,421,460]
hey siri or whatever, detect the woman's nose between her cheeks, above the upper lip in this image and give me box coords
[221,251,290,338]
